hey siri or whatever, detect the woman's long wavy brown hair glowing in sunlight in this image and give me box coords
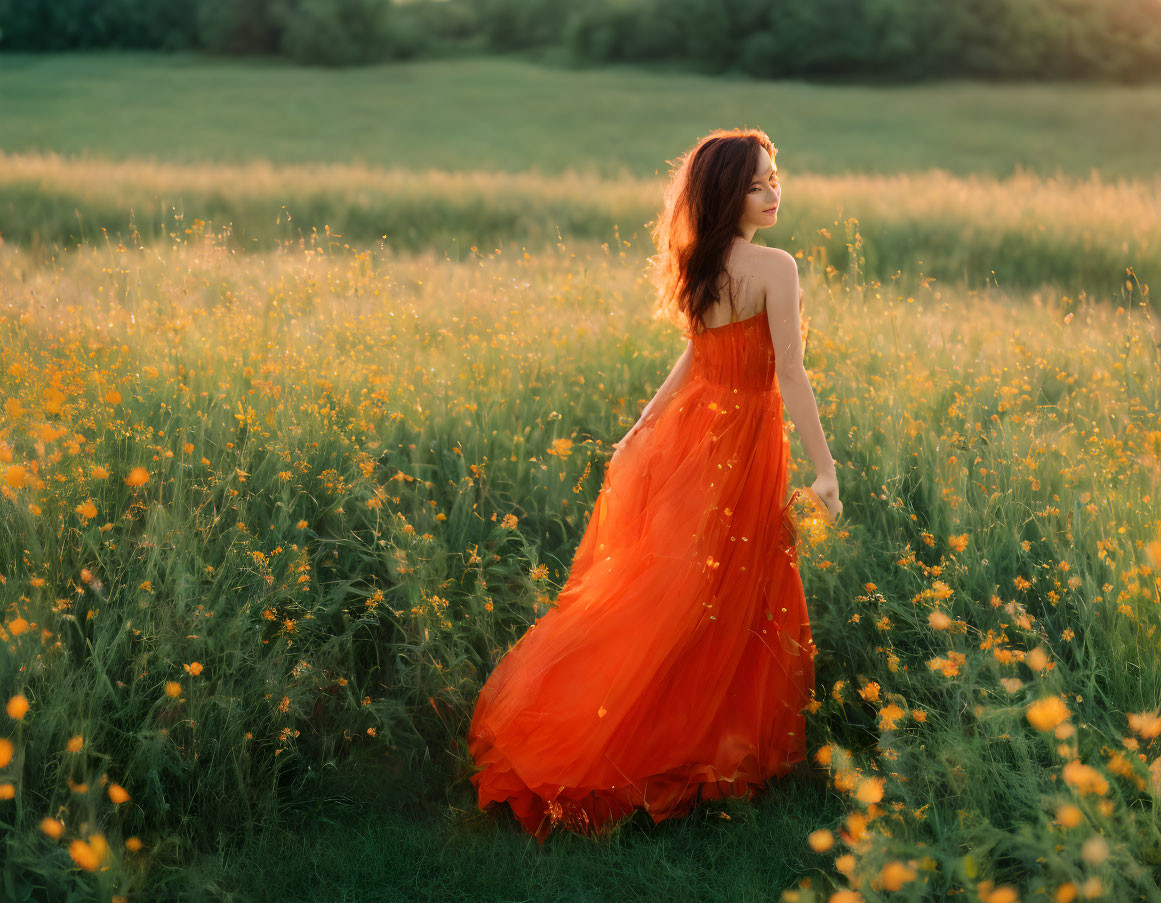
[649,129,778,337]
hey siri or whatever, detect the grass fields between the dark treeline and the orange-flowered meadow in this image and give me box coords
[0,53,1161,302]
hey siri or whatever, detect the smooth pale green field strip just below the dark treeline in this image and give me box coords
[0,52,1161,181]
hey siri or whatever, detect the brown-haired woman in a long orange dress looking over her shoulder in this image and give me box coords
[468,129,842,843]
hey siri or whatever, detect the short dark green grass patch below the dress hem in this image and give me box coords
[163,778,842,903]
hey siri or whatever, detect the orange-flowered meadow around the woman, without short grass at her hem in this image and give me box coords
[0,222,1161,900]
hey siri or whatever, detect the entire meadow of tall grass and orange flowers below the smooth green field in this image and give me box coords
[0,51,1161,903]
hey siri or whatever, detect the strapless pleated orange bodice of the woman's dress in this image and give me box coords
[691,310,778,392]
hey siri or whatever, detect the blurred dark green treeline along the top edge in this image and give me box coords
[0,0,1161,81]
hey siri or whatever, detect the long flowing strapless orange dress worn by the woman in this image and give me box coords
[468,311,817,844]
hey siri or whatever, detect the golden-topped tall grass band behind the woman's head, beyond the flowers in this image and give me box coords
[0,153,1161,304]
